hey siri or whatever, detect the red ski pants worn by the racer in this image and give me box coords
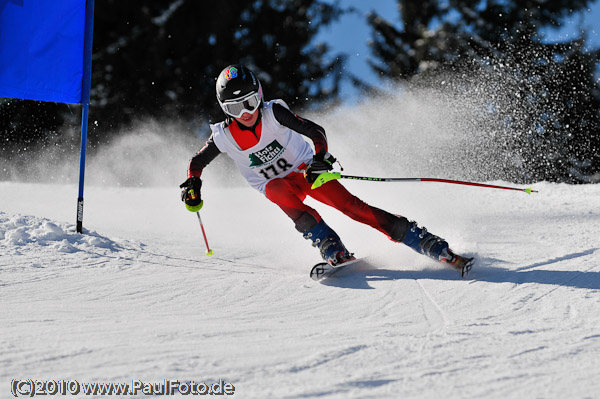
[265,172,408,241]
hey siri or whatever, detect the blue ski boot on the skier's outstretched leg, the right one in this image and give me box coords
[402,222,474,277]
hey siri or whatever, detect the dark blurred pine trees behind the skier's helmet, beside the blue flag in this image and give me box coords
[93,0,341,128]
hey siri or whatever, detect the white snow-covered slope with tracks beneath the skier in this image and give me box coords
[0,182,600,398]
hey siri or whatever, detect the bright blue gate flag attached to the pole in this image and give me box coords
[0,0,89,104]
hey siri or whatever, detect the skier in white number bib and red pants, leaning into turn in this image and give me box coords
[180,64,472,275]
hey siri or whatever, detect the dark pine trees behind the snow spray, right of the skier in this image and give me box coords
[369,0,600,182]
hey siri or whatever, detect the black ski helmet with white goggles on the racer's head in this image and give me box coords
[216,64,263,118]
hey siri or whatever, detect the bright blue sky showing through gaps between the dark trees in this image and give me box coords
[318,0,600,101]
